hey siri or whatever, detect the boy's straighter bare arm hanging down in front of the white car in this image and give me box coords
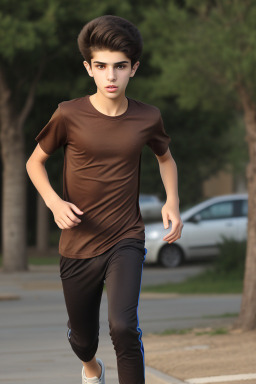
[156,148,183,243]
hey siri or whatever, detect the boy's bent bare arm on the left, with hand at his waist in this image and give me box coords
[26,144,83,229]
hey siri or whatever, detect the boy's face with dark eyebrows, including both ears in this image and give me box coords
[83,50,140,99]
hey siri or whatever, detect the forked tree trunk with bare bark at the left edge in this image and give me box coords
[0,63,43,272]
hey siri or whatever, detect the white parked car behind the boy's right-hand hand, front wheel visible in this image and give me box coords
[145,193,248,268]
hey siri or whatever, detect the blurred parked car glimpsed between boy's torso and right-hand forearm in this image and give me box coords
[139,193,164,223]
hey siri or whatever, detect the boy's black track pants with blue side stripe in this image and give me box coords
[60,238,147,384]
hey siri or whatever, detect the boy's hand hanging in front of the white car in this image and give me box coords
[161,202,183,244]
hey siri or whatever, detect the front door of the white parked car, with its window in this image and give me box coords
[186,200,238,256]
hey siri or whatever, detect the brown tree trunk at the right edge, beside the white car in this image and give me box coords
[234,89,256,331]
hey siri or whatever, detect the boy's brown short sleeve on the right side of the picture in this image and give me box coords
[146,112,171,156]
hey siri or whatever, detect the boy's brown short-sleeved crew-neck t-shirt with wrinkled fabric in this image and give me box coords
[35,95,171,259]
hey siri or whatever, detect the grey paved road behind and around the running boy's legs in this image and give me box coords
[0,267,241,384]
